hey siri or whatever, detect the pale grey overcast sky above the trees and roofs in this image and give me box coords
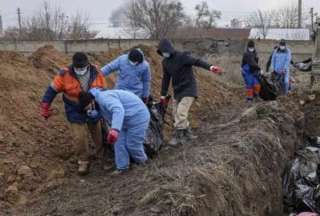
[0,0,320,27]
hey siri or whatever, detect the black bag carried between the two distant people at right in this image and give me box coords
[258,74,279,101]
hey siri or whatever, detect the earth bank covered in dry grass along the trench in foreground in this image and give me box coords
[8,98,304,216]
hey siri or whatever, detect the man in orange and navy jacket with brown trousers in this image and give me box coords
[40,52,106,175]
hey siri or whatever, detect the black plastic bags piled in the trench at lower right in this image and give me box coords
[283,142,320,213]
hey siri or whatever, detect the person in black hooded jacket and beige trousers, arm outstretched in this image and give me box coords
[158,39,222,146]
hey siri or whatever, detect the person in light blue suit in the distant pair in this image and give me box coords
[271,40,292,95]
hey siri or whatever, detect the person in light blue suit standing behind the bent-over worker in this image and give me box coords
[101,49,151,103]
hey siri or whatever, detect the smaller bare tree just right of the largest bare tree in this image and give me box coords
[195,1,221,28]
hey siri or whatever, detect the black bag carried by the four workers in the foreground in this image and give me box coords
[102,96,171,158]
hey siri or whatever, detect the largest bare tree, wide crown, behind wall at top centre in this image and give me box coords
[127,0,186,39]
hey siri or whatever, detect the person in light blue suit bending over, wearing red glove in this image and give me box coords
[80,88,150,173]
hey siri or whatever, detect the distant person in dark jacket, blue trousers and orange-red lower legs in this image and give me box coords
[241,40,261,103]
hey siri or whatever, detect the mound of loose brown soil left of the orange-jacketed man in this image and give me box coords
[0,49,72,210]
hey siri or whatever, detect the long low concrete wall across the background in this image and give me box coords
[0,39,314,59]
